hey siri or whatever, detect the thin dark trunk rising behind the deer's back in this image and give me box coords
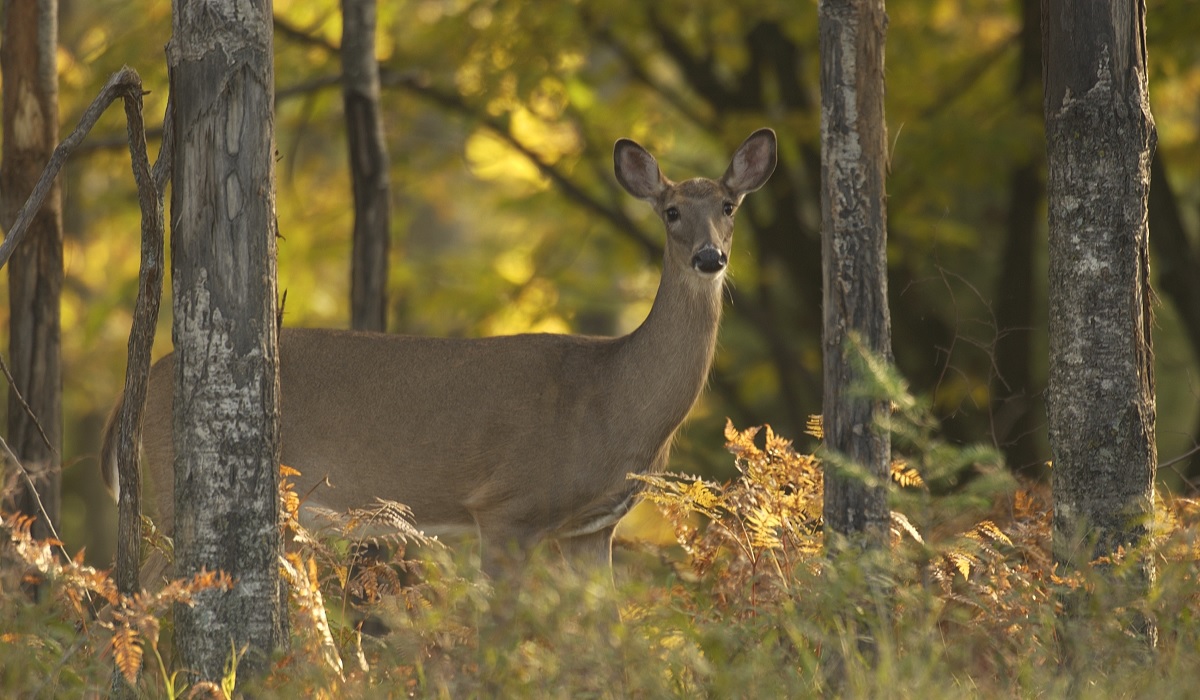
[342,0,390,331]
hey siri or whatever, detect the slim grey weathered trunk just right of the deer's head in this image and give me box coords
[817,0,892,548]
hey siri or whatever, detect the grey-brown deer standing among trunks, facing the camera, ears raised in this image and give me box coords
[101,128,775,576]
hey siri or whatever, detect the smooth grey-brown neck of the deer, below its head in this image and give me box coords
[619,259,722,443]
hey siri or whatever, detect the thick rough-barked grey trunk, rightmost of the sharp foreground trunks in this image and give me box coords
[1043,0,1157,602]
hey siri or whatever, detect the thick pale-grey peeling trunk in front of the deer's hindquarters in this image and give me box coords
[167,0,282,681]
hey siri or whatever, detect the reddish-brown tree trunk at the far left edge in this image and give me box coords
[0,0,62,538]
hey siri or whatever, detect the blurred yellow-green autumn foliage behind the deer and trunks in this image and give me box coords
[0,0,1200,563]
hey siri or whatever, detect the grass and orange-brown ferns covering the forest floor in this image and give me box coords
[0,386,1200,698]
